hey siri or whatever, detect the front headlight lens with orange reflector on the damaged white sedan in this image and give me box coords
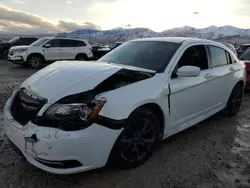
[45,98,106,123]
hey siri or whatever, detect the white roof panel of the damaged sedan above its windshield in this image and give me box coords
[132,37,219,44]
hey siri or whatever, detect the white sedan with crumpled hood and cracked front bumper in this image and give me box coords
[4,38,245,174]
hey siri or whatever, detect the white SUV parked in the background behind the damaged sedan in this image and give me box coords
[8,38,93,68]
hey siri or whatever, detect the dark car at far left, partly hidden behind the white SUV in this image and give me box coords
[0,37,38,59]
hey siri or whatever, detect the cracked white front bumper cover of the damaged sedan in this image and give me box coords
[4,96,122,174]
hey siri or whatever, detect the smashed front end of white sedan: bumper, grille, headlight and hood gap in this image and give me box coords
[4,69,154,174]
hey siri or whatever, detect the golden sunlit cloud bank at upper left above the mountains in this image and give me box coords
[0,4,100,33]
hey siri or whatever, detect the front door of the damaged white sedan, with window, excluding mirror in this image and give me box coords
[170,45,216,131]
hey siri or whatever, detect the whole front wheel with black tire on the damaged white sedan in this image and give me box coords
[109,108,160,169]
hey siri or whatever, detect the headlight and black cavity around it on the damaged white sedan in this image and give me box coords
[34,98,106,131]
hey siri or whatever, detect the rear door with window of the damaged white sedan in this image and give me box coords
[208,45,240,106]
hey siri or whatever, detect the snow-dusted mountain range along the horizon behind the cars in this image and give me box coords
[57,26,250,45]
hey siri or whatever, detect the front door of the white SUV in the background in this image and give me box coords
[43,39,61,61]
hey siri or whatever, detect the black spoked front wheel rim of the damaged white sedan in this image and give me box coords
[120,119,156,163]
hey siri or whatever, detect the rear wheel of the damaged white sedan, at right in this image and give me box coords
[223,83,243,117]
